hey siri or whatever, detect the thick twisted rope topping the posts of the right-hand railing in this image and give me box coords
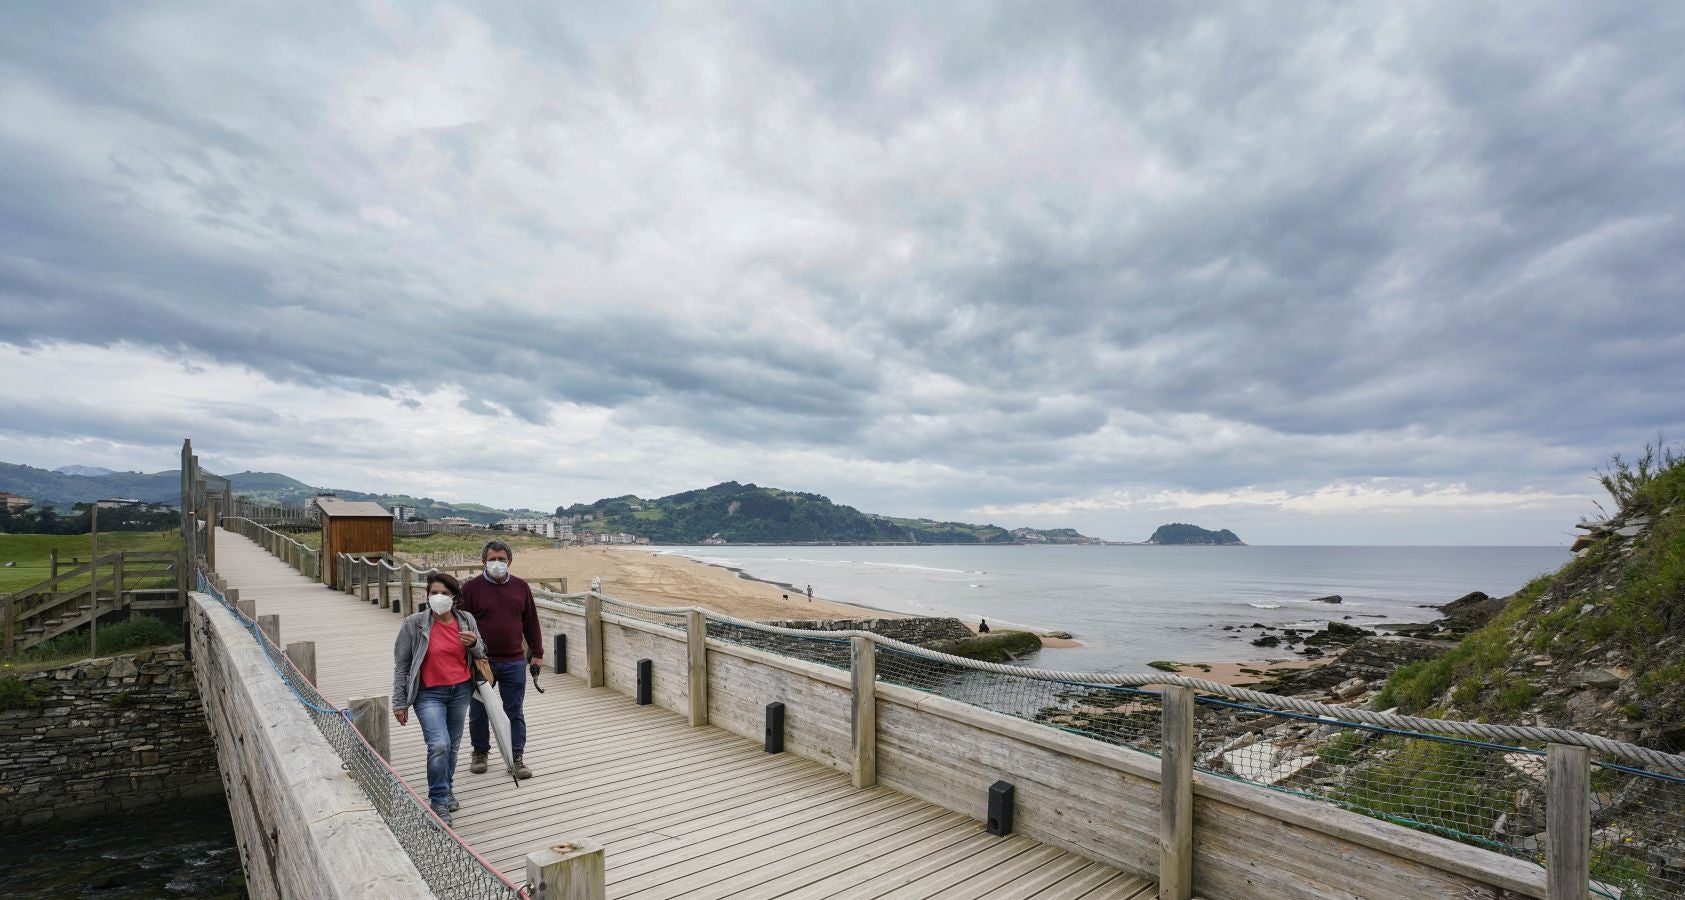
[572,593,1685,774]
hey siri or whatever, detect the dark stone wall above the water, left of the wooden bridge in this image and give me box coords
[0,644,222,831]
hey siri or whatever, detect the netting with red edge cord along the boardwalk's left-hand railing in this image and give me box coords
[197,571,526,900]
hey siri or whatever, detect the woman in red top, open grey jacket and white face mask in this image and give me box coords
[393,571,485,824]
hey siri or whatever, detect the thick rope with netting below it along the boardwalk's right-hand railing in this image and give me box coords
[570,593,1685,898]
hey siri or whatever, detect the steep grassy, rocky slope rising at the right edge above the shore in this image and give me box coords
[1377,447,1685,753]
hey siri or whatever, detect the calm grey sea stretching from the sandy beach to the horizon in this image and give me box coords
[661,544,1569,672]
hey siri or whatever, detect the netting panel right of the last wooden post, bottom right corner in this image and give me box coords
[1591,762,1685,900]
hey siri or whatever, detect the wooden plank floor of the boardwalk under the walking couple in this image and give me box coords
[216,529,1156,900]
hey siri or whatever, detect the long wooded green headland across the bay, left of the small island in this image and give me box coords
[556,482,1089,544]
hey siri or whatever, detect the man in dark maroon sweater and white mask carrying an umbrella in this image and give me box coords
[462,541,544,779]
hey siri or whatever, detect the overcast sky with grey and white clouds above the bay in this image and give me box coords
[0,0,1685,544]
